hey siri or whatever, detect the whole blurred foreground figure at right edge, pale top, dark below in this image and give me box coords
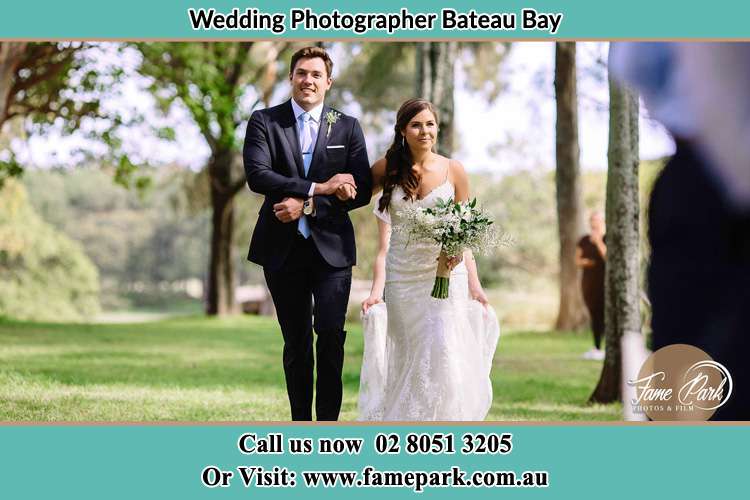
[610,43,750,420]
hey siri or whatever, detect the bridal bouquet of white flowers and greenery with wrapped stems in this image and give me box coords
[399,198,512,299]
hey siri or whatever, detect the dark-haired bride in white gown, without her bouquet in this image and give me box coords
[359,99,500,421]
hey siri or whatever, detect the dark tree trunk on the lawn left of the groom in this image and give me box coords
[206,151,238,316]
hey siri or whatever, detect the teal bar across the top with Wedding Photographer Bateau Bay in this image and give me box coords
[0,0,750,40]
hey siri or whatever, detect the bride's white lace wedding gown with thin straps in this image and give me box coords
[359,181,500,421]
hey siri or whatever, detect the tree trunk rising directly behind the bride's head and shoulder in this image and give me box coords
[416,42,458,156]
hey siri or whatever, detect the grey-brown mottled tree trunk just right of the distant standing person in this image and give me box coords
[590,72,641,403]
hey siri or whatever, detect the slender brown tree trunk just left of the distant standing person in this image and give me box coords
[555,42,588,330]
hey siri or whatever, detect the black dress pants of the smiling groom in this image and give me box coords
[264,234,352,420]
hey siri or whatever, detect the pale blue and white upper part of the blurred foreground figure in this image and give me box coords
[609,42,750,212]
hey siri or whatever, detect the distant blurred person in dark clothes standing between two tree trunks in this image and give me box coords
[576,212,607,360]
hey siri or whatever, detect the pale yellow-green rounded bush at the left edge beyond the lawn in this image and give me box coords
[0,180,99,321]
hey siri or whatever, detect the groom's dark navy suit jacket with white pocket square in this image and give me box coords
[243,100,372,270]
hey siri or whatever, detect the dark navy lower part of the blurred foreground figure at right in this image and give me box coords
[648,139,750,420]
